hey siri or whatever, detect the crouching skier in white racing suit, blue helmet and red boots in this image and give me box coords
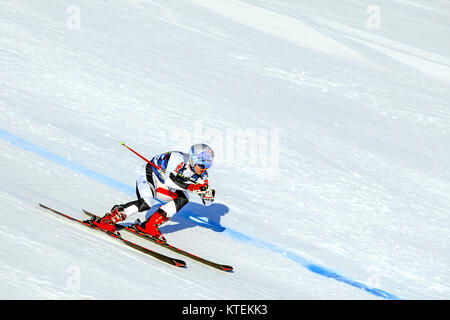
[90,144,215,242]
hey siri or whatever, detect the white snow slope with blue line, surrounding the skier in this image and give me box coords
[0,0,450,299]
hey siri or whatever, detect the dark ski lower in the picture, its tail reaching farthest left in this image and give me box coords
[39,203,186,267]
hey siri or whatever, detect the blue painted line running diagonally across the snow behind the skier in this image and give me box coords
[0,129,399,300]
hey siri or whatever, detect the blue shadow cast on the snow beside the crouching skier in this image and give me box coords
[159,202,229,234]
